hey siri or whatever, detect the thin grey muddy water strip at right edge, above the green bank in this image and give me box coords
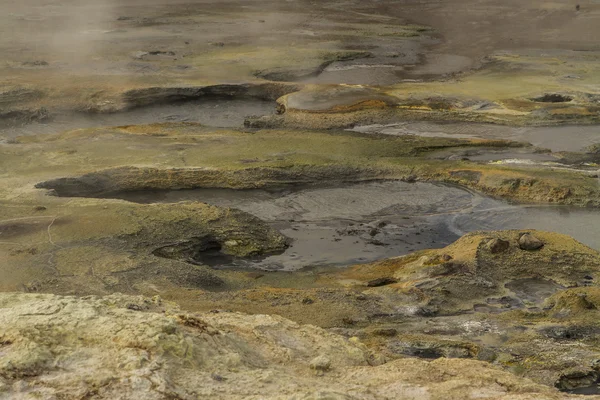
[353,122,600,151]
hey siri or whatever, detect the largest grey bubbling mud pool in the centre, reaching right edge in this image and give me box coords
[114,181,600,270]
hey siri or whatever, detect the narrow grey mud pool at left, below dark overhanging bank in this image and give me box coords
[0,99,275,141]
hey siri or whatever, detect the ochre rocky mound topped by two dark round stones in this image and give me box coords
[341,231,600,314]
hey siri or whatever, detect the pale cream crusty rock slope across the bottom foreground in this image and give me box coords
[0,293,592,400]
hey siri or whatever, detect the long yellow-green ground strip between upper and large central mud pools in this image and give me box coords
[8,124,599,206]
